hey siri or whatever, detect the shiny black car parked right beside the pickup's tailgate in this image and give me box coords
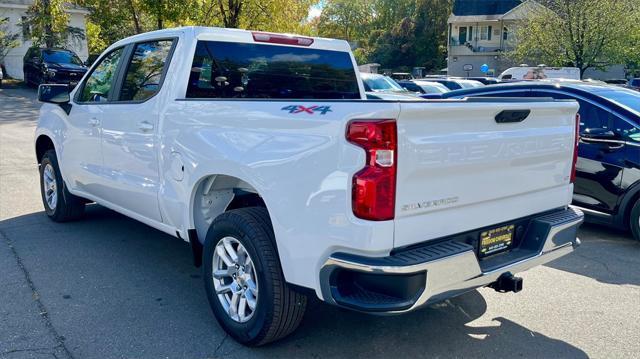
[422,81,640,239]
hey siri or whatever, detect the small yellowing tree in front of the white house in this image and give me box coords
[24,0,85,47]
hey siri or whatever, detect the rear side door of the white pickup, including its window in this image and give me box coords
[97,39,173,222]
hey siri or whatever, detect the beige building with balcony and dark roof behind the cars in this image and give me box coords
[447,0,545,76]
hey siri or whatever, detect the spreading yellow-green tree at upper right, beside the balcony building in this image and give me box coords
[509,0,638,75]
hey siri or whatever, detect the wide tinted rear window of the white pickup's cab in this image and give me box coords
[187,40,360,99]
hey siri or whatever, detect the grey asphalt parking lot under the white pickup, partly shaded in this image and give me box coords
[0,88,640,358]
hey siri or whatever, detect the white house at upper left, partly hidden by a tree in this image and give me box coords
[0,0,89,79]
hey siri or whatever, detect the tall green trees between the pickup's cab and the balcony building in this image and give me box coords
[313,0,452,70]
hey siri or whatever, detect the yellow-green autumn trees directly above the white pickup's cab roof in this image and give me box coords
[75,0,315,53]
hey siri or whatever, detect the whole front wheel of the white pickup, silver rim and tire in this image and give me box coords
[40,150,85,222]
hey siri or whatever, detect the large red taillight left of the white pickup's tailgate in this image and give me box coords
[347,120,398,221]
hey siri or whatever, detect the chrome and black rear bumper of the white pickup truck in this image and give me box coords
[320,207,584,313]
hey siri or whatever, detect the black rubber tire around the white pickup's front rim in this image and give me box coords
[40,150,85,222]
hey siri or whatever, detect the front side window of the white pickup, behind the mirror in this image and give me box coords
[79,48,123,102]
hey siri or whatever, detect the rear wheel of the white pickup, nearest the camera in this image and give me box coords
[203,207,307,346]
